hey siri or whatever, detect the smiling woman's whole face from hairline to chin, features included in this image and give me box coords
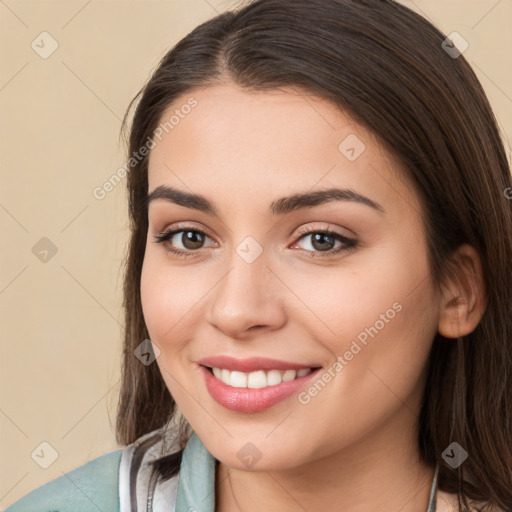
[141,84,439,470]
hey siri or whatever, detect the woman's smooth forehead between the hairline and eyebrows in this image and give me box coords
[148,83,415,218]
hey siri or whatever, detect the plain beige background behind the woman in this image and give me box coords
[0,0,512,508]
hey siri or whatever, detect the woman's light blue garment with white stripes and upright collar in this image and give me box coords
[4,430,438,512]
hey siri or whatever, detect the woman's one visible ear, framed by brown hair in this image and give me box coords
[438,244,487,338]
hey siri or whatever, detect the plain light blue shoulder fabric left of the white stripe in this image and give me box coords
[4,450,122,512]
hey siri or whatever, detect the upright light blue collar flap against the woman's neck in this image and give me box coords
[176,432,215,512]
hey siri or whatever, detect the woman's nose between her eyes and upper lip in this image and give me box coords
[209,251,286,339]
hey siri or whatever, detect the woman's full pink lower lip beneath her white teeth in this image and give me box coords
[201,366,319,412]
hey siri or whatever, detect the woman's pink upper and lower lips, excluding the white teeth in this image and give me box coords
[199,356,319,412]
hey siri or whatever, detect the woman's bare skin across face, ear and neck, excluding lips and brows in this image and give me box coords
[141,82,485,512]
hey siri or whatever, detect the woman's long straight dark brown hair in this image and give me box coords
[117,0,512,510]
